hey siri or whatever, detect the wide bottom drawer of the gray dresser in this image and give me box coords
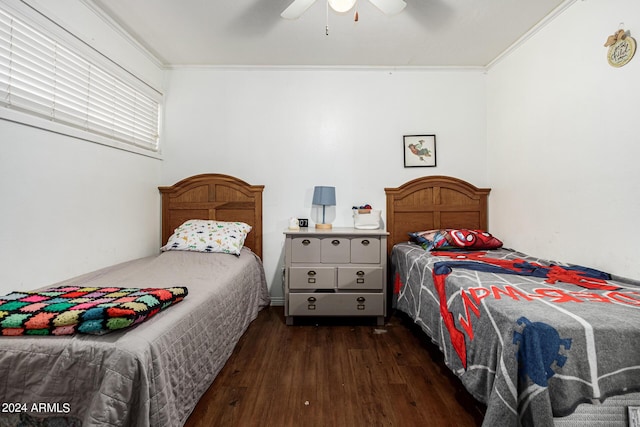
[288,292,384,316]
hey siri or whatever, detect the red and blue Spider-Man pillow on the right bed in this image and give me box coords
[409,229,502,251]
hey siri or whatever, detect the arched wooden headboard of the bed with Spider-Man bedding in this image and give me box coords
[384,175,491,253]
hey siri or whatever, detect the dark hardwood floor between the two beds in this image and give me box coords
[185,307,484,427]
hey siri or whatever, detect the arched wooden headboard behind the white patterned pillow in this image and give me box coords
[158,174,264,259]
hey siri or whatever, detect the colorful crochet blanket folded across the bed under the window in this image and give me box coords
[0,286,188,336]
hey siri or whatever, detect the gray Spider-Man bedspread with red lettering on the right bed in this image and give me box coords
[391,243,640,426]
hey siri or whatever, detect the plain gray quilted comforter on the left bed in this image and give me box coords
[0,249,269,427]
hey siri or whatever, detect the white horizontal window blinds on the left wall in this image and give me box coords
[0,9,159,152]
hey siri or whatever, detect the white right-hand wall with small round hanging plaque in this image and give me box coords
[487,0,640,279]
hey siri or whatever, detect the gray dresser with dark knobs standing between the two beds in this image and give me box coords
[284,228,388,325]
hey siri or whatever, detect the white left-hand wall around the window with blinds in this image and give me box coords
[0,0,163,294]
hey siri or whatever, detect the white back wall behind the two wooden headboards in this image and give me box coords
[162,68,488,301]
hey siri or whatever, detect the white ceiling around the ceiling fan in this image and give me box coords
[85,0,567,67]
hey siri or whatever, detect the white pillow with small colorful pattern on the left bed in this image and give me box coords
[161,219,251,255]
